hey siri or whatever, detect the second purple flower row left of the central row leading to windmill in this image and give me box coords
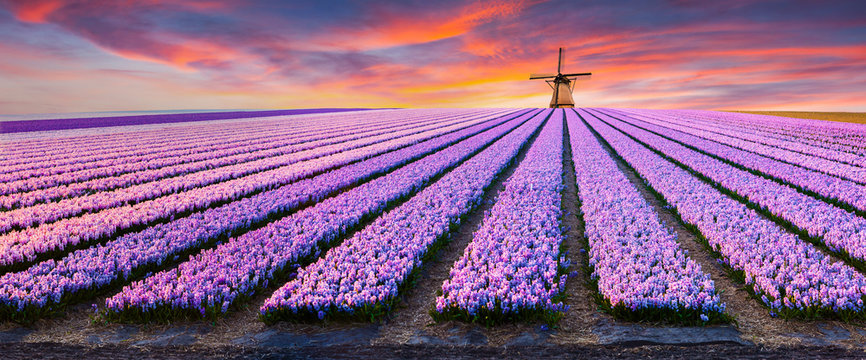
[105,109,537,320]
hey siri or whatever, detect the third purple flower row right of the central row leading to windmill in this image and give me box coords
[599,109,866,270]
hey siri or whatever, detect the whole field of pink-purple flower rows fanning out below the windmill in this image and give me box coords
[0,108,866,326]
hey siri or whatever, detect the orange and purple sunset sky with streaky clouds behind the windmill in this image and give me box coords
[0,0,866,114]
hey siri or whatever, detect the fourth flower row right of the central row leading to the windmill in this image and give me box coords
[604,108,866,211]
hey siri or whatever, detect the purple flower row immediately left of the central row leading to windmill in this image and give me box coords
[260,110,550,319]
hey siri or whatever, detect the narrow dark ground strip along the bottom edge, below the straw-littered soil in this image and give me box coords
[0,343,866,360]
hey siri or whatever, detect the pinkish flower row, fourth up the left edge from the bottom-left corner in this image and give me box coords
[0,111,502,209]
